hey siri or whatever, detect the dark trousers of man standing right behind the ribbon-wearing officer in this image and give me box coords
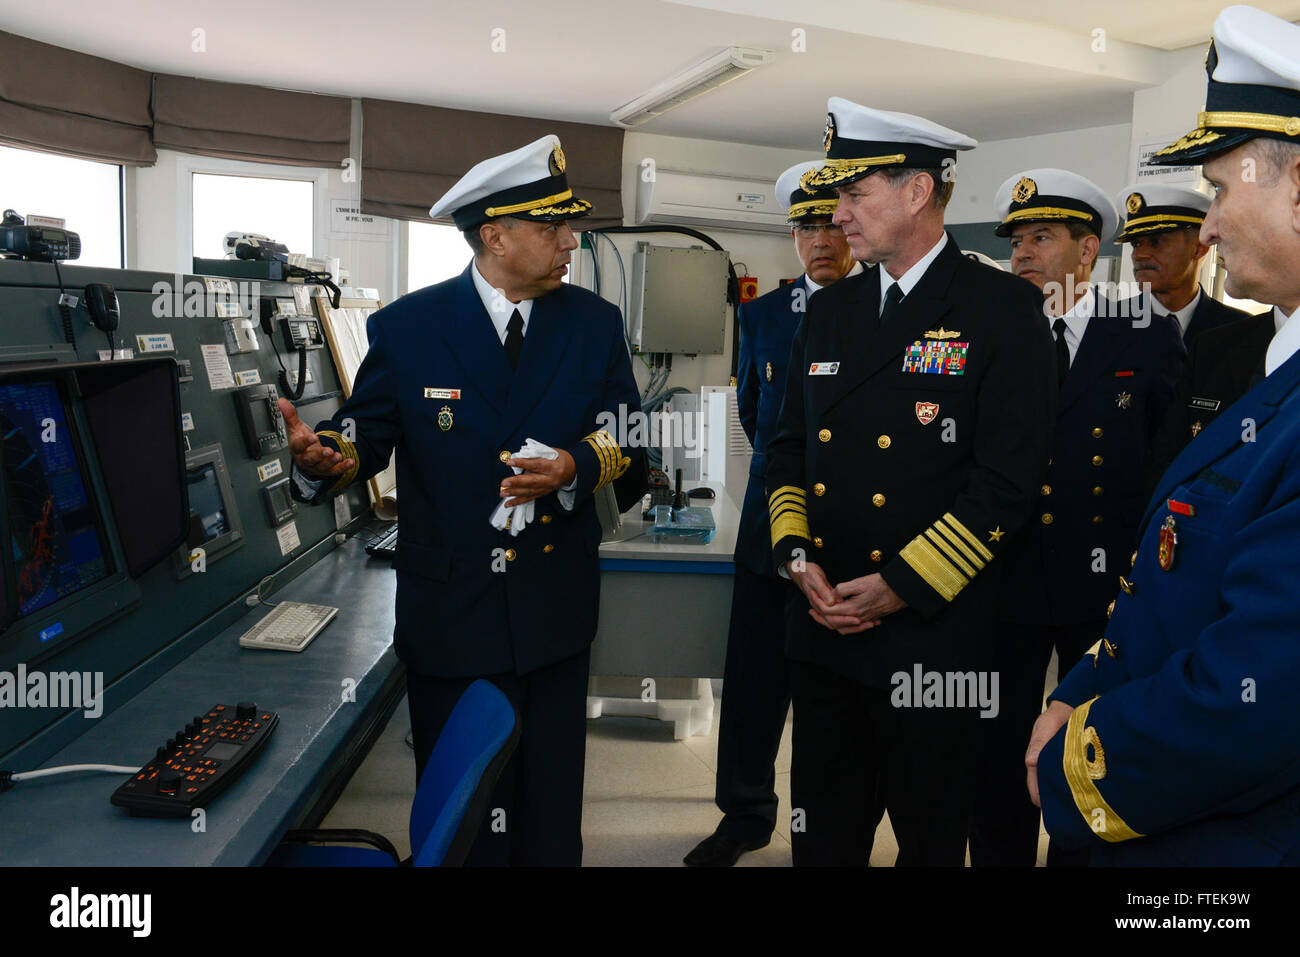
[971,619,1106,867]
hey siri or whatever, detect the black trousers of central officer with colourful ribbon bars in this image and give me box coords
[790,657,980,867]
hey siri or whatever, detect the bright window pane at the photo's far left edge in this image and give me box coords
[0,147,124,269]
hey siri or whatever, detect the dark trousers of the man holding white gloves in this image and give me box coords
[407,649,590,867]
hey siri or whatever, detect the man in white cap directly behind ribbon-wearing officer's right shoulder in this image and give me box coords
[971,169,1184,867]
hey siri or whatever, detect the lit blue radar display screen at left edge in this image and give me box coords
[0,380,111,615]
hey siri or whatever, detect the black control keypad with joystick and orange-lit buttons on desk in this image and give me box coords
[112,701,280,818]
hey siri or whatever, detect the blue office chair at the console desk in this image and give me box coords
[267,679,519,867]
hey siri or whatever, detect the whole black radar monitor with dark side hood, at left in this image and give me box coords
[0,359,187,668]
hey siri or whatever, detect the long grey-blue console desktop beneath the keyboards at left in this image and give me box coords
[0,537,397,866]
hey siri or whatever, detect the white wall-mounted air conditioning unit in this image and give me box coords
[637,168,790,235]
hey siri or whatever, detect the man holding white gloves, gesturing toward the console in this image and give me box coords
[281,137,645,865]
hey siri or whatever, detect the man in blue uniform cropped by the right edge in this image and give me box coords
[1026,7,1300,866]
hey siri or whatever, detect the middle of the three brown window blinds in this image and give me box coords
[153,74,352,166]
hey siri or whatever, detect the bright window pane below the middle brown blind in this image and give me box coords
[191,170,316,259]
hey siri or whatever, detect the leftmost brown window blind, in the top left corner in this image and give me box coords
[0,33,157,166]
